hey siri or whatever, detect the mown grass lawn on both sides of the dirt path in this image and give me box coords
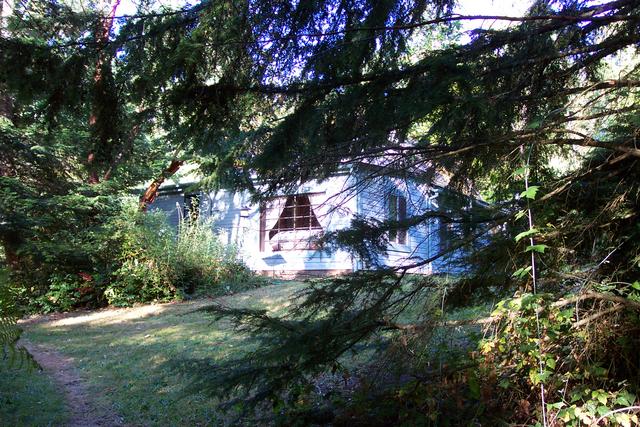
[9,282,302,426]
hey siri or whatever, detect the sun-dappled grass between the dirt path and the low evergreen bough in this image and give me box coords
[15,282,304,425]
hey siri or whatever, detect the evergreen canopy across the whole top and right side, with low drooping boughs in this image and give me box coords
[0,0,640,424]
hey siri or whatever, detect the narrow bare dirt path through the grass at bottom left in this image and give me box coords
[20,339,124,427]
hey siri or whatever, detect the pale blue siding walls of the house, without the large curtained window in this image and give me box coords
[150,171,468,278]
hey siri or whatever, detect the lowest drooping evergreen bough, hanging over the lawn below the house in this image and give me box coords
[190,270,448,409]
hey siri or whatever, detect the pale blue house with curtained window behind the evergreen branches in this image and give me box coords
[150,165,472,278]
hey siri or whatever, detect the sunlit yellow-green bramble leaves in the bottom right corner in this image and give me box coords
[479,291,640,426]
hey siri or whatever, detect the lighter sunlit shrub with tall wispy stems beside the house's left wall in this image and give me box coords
[104,203,253,306]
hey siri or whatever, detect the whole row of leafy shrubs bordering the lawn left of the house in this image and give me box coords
[4,196,254,312]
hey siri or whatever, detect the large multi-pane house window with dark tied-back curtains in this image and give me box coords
[260,194,322,252]
